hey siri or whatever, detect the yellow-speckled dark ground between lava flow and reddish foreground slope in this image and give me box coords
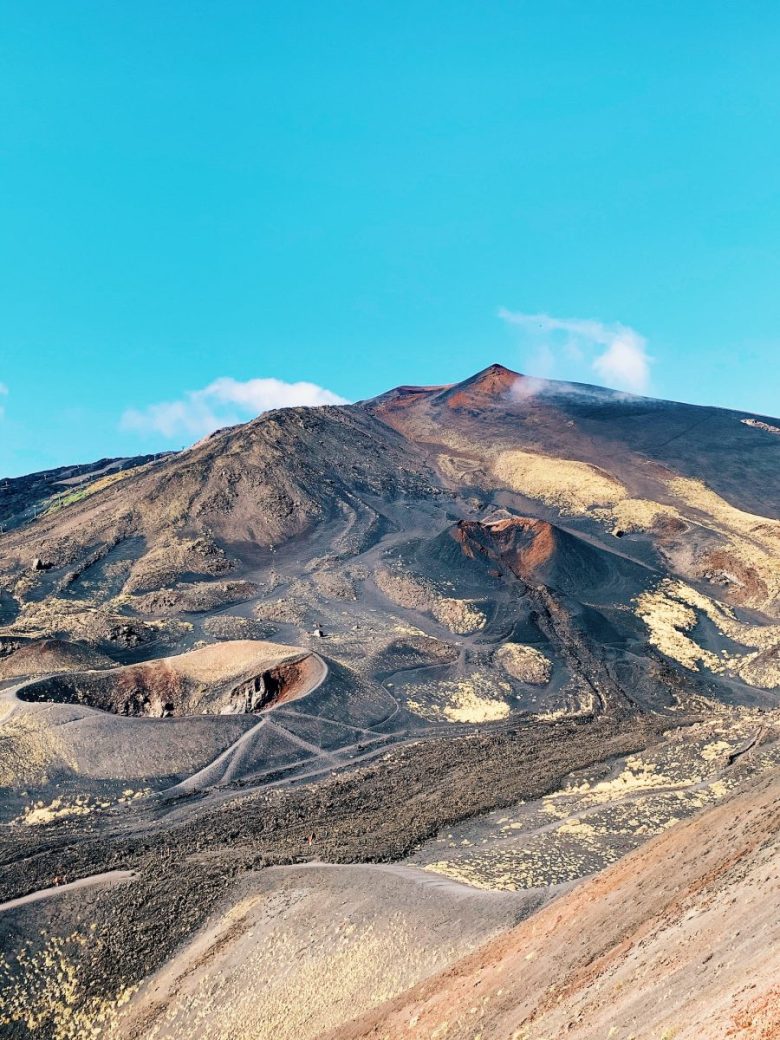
[411,708,780,890]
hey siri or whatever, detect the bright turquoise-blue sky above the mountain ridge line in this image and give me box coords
[0,0,780,474]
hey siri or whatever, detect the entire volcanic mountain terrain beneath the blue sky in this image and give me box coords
[0,365,780,1040]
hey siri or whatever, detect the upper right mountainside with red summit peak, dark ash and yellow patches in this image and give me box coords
[365,365,780,616]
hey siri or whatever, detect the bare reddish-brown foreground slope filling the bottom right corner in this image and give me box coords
[331,775,780,1040]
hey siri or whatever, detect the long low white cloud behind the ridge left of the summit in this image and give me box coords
[120,375,346,439]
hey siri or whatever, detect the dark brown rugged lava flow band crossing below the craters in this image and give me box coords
[0,718,682,1040]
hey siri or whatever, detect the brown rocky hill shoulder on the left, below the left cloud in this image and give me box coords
[2,408,435,613]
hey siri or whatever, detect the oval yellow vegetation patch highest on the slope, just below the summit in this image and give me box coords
[493,450,628,515]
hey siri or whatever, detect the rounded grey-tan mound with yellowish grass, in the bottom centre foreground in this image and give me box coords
[119,866,511,1040]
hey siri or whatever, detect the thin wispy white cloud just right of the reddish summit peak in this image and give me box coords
[498,307,651,393]
